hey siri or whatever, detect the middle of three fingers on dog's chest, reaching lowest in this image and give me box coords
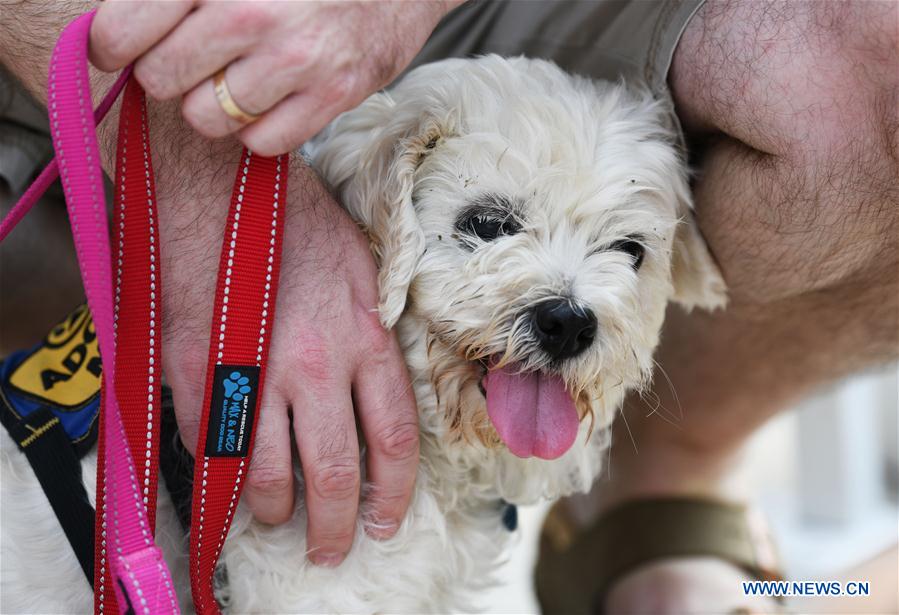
[293,381,360,566]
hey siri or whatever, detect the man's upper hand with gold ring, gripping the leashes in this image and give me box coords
[91,0,459,155]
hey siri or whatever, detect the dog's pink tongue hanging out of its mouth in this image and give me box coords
[484,365,579,459]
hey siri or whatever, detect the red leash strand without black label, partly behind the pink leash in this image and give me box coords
[94,77,171,613]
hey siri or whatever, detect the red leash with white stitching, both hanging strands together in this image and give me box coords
[95,79,287,614]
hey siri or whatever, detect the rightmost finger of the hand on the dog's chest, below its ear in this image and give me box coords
[353,325,419,538]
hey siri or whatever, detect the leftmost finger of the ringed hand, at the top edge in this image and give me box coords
[90,0,194,71]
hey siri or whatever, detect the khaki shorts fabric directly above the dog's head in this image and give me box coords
[412,0,705,145]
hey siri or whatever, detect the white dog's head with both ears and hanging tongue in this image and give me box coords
[315,56,724,470]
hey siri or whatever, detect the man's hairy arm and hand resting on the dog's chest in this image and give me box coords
[0,0,418,565]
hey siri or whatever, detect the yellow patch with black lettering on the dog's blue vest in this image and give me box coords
[9,305,102,407]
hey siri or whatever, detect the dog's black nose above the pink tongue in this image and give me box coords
[534,299,596,359]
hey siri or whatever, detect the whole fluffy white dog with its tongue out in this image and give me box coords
[2,56,725,613]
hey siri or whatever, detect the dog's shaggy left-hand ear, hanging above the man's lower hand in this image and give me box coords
[311,93,441,329]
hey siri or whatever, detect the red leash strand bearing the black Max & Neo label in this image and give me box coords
[190,138,287,614]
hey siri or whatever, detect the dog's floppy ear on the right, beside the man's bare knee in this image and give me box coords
[671,209,727,310]
